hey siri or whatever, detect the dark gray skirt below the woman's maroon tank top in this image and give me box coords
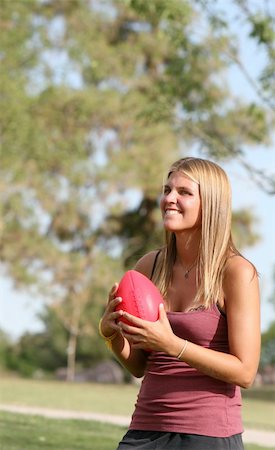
[117,430,244,450]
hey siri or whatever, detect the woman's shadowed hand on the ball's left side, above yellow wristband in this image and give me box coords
[101,283,123,338]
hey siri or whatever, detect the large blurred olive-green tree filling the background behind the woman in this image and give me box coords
[0,0,275,380]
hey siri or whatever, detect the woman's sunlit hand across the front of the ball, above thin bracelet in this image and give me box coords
[118,304,174,353]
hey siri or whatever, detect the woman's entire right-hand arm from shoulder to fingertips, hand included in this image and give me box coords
[121,256,261,388]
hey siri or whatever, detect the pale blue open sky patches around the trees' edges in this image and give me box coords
[0,0,275,339]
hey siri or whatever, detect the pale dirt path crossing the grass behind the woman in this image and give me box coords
[0,404,275,449]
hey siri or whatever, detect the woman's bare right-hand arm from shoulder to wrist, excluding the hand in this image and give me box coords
[183,256,261,388]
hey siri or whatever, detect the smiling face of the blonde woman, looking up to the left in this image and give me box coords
[160,172,201,233]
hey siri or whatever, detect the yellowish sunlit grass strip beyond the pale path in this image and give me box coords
[0,377,275,432]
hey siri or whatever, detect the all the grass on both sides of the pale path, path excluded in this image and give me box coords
[0,377,275,450]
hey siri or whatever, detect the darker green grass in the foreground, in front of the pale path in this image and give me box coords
[0,413,275,450]
